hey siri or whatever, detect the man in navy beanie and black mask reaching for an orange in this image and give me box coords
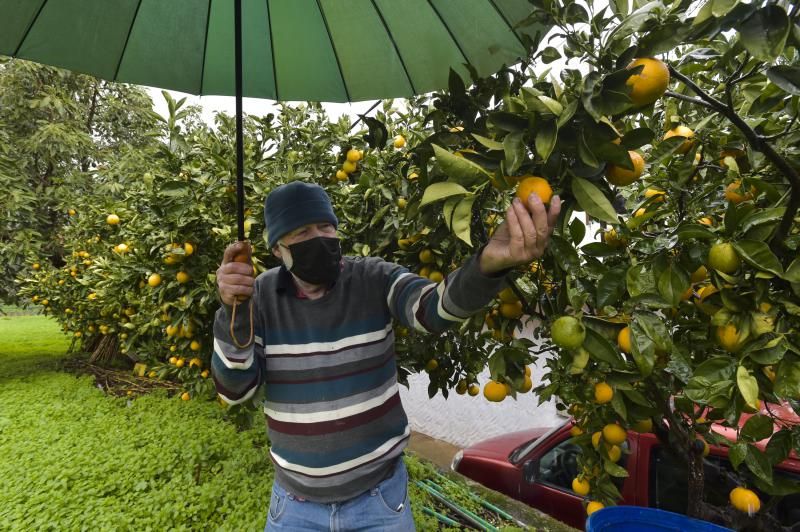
[212,181,561,531]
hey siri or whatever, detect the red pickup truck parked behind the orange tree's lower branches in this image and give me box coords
[452,412,800,532]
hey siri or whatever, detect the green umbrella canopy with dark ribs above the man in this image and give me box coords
[0,0,549,102]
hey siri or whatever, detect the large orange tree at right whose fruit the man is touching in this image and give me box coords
[366,1,800,529]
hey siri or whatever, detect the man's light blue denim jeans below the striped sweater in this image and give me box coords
[264,458,416,532]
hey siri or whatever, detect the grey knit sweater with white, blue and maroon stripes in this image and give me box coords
[211,256,503,502]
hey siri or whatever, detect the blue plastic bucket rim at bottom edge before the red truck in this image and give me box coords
[586,506,731,532]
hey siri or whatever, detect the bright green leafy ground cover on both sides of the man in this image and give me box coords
[0,315,572,531]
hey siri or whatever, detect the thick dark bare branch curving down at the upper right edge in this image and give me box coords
[669,65,800,251]
